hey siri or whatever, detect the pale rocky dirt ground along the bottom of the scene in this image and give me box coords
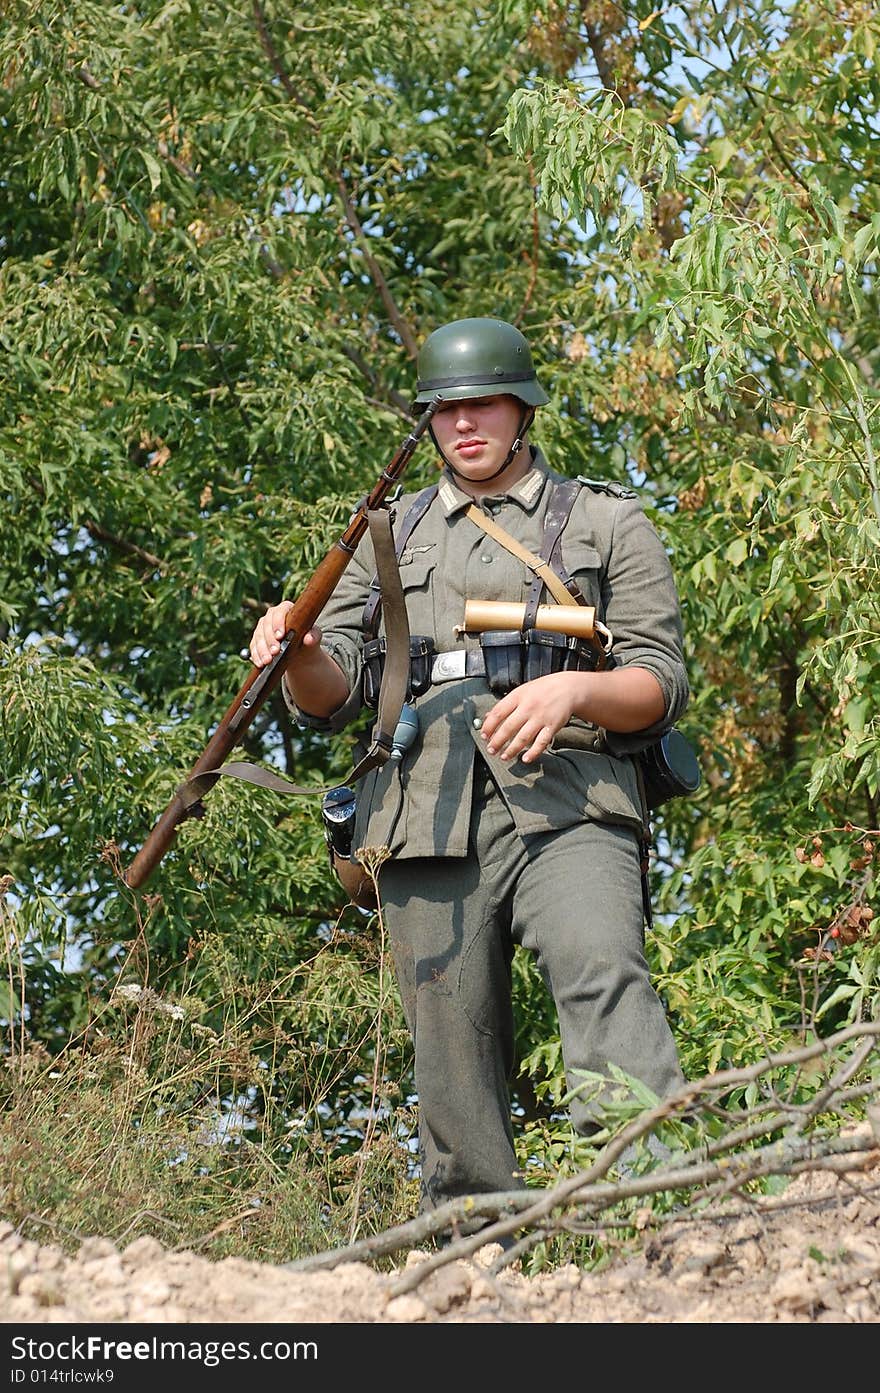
[0,1167,880,1325]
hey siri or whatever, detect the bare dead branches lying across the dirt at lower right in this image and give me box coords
[285,1021,880,1295]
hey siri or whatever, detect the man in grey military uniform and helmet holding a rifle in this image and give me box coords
[251,319,688,1209]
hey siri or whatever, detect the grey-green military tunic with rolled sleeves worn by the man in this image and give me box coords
[292,447,688,858]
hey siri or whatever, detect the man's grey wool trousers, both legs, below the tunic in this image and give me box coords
[380,756,684,1209]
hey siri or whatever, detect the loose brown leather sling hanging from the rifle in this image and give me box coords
[177,508,409,815]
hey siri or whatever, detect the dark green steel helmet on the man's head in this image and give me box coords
[412,319,550,411]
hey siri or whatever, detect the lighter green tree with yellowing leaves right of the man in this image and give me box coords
[504,3,880,1067]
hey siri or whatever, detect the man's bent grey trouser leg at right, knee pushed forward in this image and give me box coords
[512,822,684,1131]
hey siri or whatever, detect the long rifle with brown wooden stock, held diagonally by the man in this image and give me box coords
[124,394,443,890]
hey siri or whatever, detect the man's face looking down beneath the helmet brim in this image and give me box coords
[432,396,531,486]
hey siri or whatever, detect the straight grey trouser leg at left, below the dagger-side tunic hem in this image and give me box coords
[382,780,522,1208]
